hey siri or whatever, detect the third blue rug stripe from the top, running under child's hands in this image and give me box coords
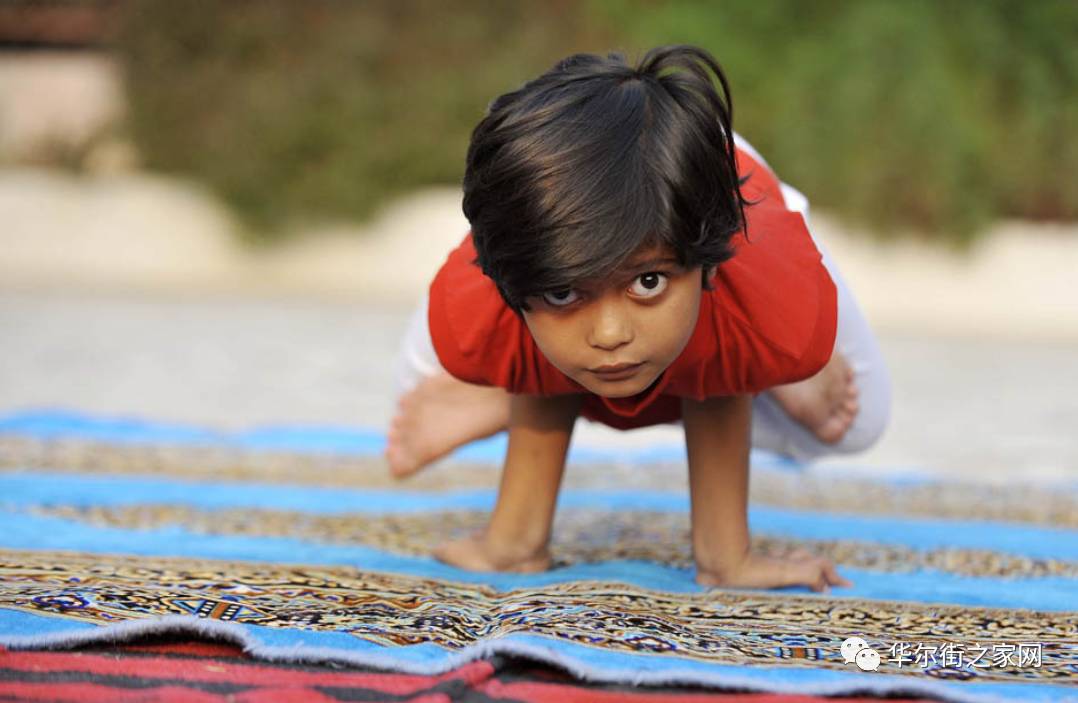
[0,512,1078,610]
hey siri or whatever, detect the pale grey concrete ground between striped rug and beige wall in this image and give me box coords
[0,291,1078,482]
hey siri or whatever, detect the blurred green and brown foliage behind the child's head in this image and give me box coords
[118,0,1078,243]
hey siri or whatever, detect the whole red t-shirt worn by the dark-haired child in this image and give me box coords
[428,150,838,429]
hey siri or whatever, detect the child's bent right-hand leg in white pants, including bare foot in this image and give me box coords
[752,183,890,460]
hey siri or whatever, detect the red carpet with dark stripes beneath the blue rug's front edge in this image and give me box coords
[0,642,940,703]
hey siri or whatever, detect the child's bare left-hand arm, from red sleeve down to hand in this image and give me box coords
[434,396,581,571]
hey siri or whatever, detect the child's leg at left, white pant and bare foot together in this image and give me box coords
[386,299,509,478]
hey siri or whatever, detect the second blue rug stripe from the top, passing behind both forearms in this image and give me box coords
[0,471,1078,561]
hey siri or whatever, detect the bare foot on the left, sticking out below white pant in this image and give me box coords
[386,373,509,479]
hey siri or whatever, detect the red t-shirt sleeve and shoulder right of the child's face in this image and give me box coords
[669,144,838,398]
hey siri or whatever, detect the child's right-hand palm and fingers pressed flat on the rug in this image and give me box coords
[696,549,853,593]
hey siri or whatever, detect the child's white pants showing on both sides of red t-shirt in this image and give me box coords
[397,171,890,460]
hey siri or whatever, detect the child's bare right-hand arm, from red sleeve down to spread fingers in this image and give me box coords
[681,396,853,591]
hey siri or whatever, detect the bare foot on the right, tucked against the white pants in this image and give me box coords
[769,352,860,444]
